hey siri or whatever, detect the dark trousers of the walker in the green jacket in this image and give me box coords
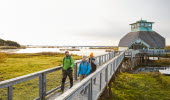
[61,70,73,91]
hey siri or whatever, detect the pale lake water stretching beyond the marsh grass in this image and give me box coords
[0,47,107,56]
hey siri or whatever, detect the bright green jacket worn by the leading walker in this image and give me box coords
[63,56,74,70]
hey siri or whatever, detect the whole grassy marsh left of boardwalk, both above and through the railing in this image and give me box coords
[0,53,81,100]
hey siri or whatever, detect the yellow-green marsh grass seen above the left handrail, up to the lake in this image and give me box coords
[0,53,81,81]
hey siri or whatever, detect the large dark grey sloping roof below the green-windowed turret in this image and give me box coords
[119,31,165,48]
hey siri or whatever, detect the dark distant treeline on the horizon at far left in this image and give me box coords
[0,39,21,48]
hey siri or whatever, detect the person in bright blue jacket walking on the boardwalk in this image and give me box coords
[78,56,91,80]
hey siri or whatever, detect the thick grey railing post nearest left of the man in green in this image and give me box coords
[39,73,46,100]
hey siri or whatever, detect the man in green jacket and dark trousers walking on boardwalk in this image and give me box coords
[60,51,74,93]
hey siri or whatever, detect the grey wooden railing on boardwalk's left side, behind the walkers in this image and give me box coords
[0,51,114,100]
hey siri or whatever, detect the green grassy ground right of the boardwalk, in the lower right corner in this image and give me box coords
[105,73,170,100]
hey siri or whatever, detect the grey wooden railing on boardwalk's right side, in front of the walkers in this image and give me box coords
[55,52,125,100]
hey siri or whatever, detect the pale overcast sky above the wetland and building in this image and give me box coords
[0,0,170,46]
